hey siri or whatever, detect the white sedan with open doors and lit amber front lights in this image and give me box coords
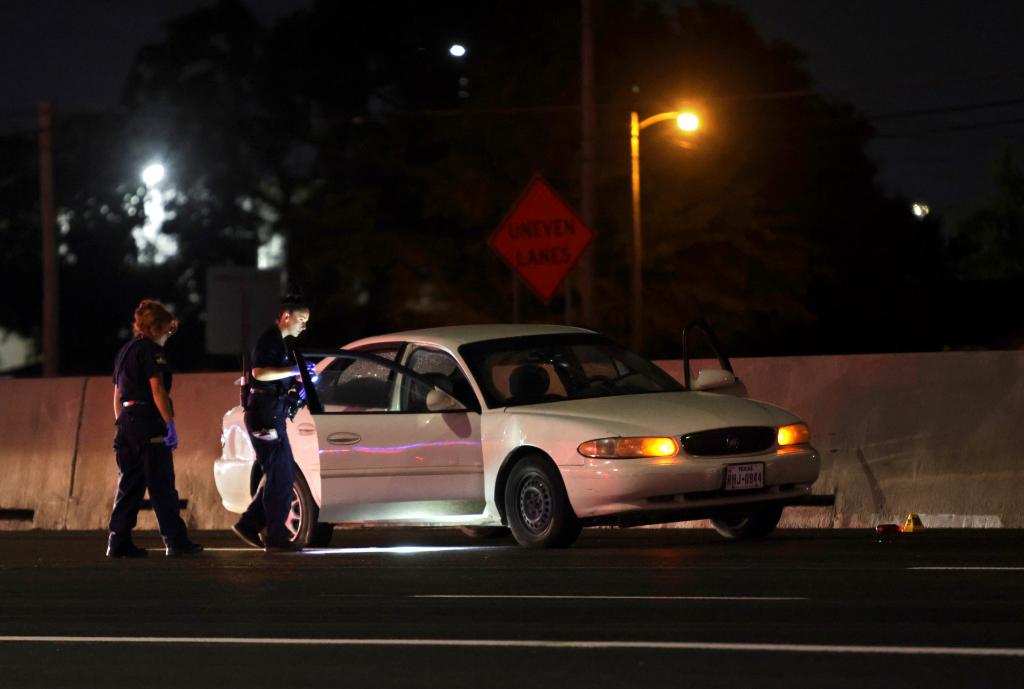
[214,325,820,548]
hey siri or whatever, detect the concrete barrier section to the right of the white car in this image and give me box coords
[662,351,1024,527]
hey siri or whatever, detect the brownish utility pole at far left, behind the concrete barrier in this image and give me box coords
[39,100,60,378]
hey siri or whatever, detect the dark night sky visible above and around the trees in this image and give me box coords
[0,0,1024,217]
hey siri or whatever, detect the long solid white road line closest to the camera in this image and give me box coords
[0,636,1024,658]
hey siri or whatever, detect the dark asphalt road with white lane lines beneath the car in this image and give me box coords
[0,529,1024,689]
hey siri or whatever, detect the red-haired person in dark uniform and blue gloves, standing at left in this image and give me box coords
[106,299,203,558]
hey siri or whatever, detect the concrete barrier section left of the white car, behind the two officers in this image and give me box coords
[0,374,239,529]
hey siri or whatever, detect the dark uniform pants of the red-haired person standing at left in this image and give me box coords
[110,413,187,548]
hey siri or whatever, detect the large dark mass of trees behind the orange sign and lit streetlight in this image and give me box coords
[0,0,945,376]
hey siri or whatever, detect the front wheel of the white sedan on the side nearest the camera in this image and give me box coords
[505,455,583,548]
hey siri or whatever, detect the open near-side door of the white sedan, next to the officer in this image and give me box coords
[296,350,484,523]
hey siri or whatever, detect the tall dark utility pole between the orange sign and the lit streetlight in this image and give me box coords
[579,0,597,328]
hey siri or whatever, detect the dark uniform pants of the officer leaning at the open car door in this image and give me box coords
[239,400,295,546]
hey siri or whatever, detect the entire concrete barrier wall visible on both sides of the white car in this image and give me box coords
[0,352,1024,529]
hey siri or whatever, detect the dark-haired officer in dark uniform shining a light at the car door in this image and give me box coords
[231,296,309,553]
